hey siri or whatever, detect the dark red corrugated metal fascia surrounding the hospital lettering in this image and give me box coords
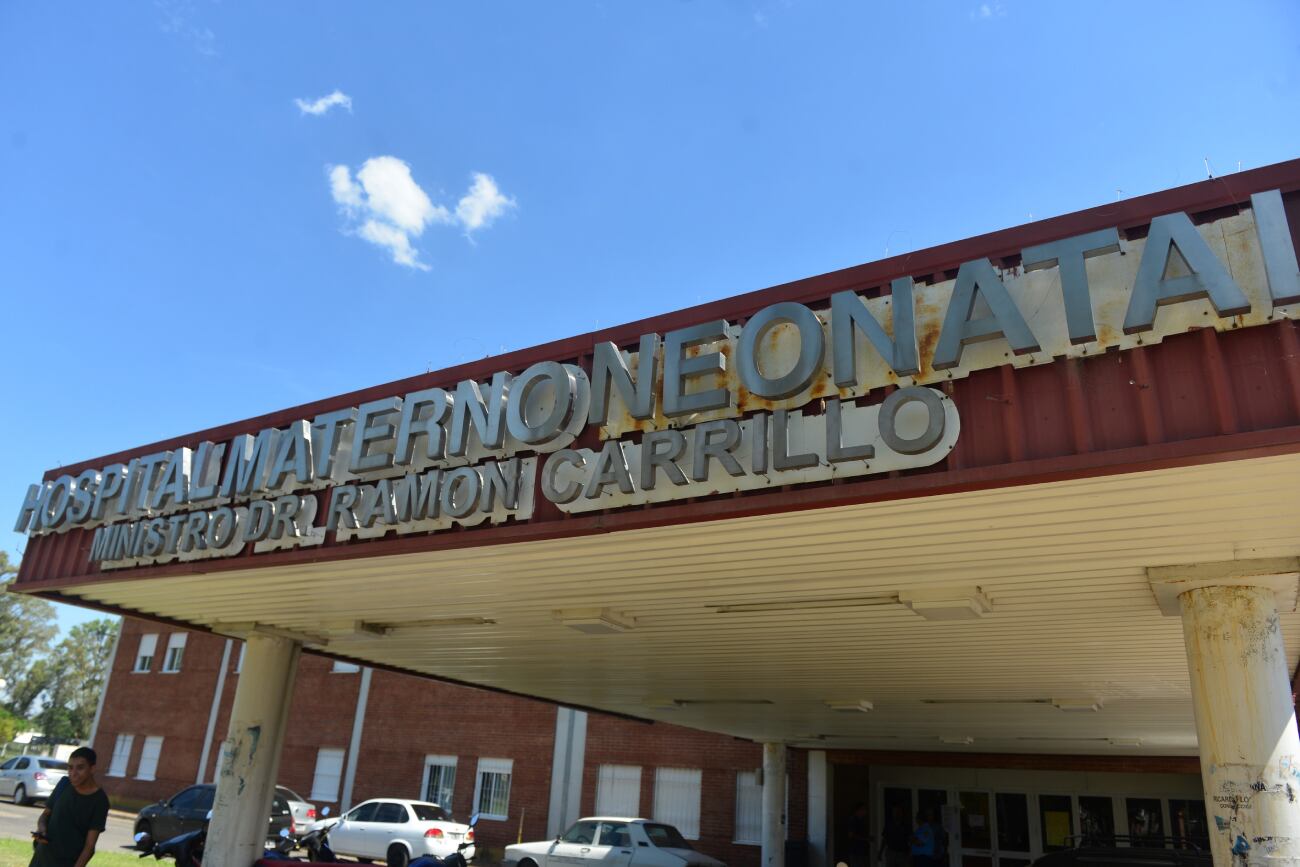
[18,160,1300,595]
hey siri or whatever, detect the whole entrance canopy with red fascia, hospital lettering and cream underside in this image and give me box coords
[16,161,1300,754]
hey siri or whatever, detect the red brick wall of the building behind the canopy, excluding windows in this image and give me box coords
[95,620,807,852]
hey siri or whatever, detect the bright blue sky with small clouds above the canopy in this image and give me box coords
[0,0,1300,636]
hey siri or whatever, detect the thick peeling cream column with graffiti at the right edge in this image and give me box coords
[1178,580,1300,867]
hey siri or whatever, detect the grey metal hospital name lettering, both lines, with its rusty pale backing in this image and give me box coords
[14,191,1300,568]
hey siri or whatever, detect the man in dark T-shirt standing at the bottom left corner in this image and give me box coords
[30,746,108,867]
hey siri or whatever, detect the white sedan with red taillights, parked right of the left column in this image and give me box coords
[319,798,475,867]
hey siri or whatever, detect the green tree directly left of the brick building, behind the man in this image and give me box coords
[33,617,118,738]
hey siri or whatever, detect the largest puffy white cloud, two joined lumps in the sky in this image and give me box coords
[328,156,515,270]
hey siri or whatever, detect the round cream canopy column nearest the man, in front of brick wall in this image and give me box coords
[203,632,303,867]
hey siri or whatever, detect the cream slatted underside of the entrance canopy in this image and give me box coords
[50,455,1300,754]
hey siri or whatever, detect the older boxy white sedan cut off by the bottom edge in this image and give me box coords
[503,816,725,867]
